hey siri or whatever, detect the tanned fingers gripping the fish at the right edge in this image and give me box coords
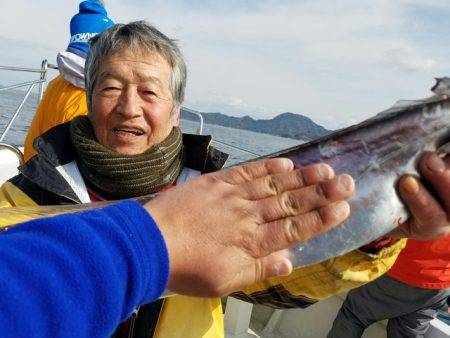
[389,152,450,240]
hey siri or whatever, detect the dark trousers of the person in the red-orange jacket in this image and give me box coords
[328,275,450,338]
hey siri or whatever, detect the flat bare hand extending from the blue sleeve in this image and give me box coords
[145,159,354,297]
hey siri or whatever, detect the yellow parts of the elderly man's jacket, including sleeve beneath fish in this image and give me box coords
[0,180,405,338]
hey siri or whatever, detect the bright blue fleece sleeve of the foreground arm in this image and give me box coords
[0,201,169,337]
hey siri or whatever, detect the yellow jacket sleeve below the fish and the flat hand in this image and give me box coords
[233,240,406,308]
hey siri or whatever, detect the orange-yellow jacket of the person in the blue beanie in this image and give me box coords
[24,75,87,162]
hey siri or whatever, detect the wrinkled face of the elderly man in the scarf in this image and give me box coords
[90,49,179,155]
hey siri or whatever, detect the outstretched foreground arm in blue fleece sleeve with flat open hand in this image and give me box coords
[0,159,354,337]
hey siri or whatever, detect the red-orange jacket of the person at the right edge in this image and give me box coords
[388,235,450,290]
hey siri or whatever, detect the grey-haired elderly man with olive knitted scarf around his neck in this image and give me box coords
[2,22,232,337]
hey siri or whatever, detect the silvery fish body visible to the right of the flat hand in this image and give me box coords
[269,78,450,267]
